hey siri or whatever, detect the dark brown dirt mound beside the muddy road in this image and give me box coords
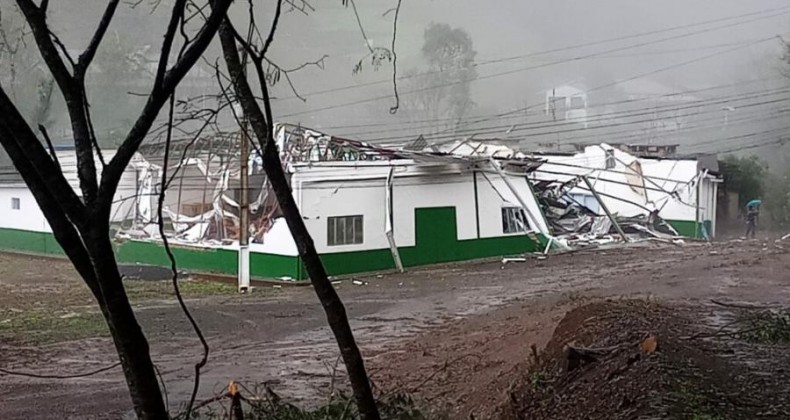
[498,301,790,420]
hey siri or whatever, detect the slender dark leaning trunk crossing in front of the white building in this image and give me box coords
[219,19,380,420]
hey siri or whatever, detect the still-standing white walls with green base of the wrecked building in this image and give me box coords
[0,153,547,280]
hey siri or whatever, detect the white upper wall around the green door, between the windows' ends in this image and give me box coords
[292,163,546,253]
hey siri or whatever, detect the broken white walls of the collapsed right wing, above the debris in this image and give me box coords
[531,144,722,239]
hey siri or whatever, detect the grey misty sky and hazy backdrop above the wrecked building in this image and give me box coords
[0,0,790,163]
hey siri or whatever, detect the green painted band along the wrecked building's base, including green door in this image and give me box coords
[0,207,545,280]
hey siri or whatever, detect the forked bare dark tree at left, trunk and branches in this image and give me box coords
[0,0,232,419]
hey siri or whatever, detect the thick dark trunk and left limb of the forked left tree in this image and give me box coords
[0,101,168,419]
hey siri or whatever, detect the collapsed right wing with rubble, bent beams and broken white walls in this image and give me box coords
[531,144,721,246]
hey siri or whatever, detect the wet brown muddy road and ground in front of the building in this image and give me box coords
[0,240,790,419]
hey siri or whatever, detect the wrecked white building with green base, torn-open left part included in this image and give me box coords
[0,125,560,279]
